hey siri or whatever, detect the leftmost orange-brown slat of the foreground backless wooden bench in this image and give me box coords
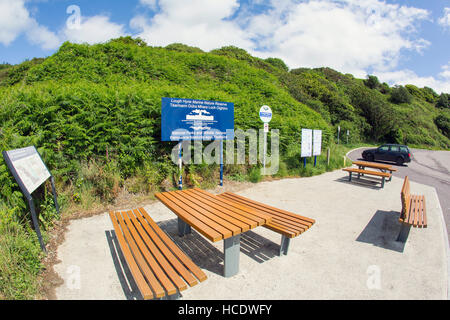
[109,211,154,300]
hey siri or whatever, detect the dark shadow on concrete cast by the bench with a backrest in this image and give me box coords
[356,210,405,252]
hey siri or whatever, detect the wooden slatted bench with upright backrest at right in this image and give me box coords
[397,176,427,242]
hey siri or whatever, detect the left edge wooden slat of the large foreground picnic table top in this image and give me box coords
[155,193,224,242]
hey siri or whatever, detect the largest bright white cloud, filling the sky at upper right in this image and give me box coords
[244,0,429,76]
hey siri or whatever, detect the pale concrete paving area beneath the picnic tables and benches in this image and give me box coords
[54,170,448,300]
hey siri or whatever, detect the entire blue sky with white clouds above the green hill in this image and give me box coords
[0,0,450,93]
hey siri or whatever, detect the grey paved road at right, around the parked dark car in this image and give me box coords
[348,148,450,245]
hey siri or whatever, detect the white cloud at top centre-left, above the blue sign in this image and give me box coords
[130,0,253,50]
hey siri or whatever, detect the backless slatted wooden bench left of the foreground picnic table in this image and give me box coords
[109,208,206,299]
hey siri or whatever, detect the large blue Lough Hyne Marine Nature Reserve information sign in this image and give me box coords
[161,98,234,141]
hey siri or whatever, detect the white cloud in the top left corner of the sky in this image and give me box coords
[0,0,60,50]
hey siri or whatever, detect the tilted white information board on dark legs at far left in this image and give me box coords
[2,146,59,252]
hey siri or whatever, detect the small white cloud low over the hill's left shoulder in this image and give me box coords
[60,15,126,44]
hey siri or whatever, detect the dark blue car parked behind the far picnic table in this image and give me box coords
[362,144,412,165]
